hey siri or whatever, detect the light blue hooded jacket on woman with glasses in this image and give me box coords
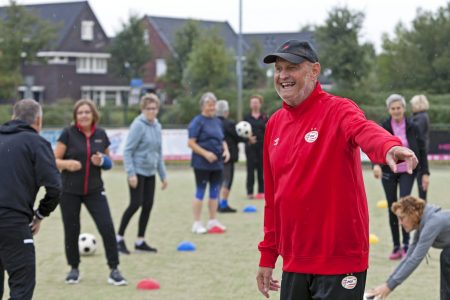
[123,114,167,180]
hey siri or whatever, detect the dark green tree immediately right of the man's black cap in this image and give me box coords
[316,7,375,89]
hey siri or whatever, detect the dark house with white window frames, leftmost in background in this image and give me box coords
[0,1,130,106]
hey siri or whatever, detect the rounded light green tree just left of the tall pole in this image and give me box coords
[183,29,234,94]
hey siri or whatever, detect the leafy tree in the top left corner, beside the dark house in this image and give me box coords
[0,0,57,99]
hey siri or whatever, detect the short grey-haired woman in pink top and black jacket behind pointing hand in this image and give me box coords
[373,94,429,260]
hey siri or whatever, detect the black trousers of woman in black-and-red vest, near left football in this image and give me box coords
[61,191,119,269]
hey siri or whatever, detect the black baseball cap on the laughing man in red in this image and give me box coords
[264,40,319,64]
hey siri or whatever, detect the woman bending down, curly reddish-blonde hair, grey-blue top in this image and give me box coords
[368,196,450,300]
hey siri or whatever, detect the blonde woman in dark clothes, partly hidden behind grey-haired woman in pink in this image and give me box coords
[409,95,430,200]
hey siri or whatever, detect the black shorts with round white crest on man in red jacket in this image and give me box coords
[280,271,367,300]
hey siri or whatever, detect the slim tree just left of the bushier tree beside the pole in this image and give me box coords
[162,20,201,98]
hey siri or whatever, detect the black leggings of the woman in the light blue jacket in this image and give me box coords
[118,175,155,237]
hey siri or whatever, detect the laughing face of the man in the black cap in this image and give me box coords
[273,58,320,107]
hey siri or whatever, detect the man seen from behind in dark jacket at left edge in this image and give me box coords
[0,99,61,299]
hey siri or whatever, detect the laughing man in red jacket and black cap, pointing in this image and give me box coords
[256,40,417,300]
